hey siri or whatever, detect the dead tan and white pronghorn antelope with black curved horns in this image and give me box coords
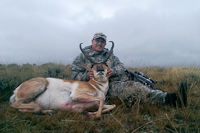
[10,41,115,118]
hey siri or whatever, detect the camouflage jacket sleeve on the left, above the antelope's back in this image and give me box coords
[71,54,90,81]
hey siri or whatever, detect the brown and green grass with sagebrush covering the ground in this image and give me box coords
[0,63,200,133]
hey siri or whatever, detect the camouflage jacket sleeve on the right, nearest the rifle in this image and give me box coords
[111,55,125,77]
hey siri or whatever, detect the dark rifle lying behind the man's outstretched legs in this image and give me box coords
[125,69,162,91]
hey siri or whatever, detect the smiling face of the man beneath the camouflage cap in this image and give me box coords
[92,38,106,52]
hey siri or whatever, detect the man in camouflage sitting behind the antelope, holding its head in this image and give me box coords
[71,33,187,106]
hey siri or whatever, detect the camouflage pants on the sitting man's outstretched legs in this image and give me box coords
[108,81,167,104]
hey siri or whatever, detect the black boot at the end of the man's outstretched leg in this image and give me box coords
[165,81,187,107]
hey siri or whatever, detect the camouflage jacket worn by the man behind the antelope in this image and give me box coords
[71,46,125,81]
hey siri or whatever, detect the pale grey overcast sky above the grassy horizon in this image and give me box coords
[0,0,200,67]
